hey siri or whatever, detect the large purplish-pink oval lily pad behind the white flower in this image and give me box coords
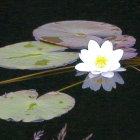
[33,20,122,49]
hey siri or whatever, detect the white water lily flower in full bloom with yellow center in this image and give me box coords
[75,40,125,78]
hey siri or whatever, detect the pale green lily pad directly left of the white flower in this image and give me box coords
[0,41,79,70]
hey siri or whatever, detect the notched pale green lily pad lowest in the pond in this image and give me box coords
[0,90,75,122]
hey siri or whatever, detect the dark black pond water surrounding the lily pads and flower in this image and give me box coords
[0,0,140,140]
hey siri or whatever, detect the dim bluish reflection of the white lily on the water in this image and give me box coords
[76,72,124,91]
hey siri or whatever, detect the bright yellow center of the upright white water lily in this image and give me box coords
[95,56,107,68]
